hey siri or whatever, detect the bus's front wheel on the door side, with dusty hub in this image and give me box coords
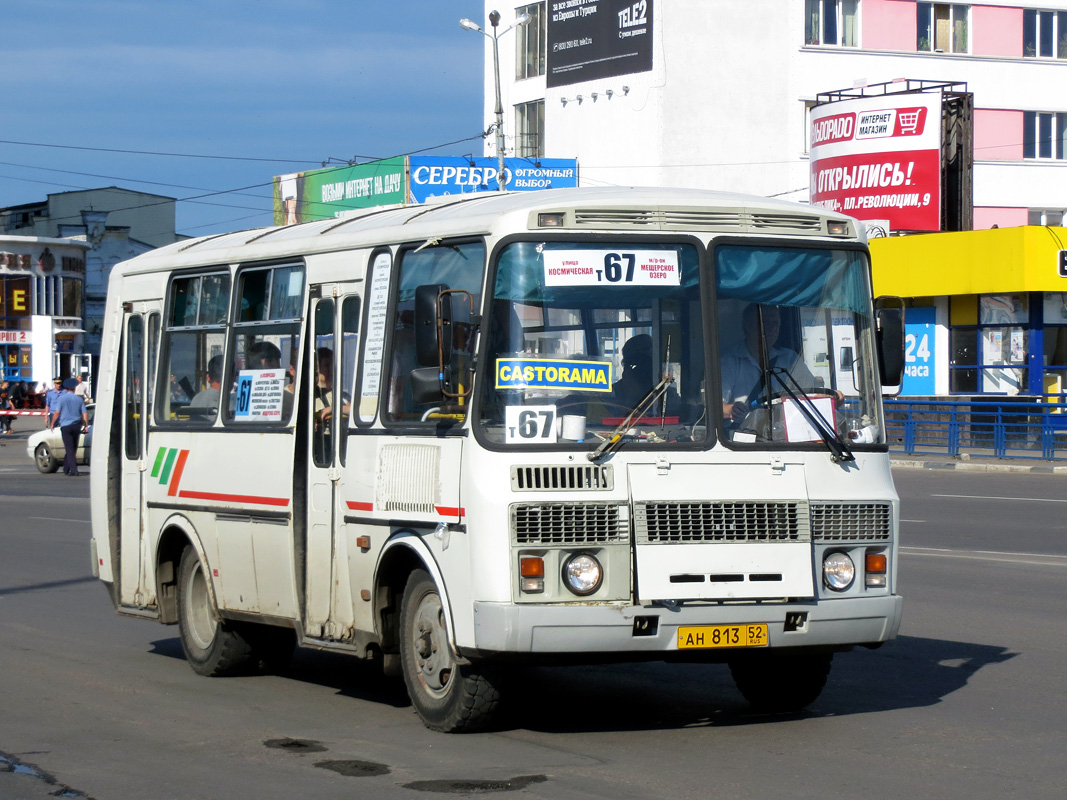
[400,570,499,733]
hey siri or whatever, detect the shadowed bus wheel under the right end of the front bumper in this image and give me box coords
[730,652,833,713]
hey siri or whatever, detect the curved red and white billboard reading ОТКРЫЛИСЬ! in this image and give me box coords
[811,93,941,230]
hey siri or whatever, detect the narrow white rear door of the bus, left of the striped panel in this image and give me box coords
[118,303,160,608]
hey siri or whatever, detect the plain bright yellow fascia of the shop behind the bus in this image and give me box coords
[871,225,1067,298]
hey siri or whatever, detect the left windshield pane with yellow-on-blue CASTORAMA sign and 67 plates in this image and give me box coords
[479,241,706,447]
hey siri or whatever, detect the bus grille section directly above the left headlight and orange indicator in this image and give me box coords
[511,502,630,545]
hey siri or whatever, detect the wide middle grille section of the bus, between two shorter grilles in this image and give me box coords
[634,502,809,543]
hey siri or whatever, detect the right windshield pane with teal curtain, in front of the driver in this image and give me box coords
[714,244,885,446]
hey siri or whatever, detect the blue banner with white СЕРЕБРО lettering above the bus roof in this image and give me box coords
[408,156,578,203]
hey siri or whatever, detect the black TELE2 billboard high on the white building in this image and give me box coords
[545,0,653,89]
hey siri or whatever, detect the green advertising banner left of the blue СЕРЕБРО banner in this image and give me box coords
[274,156,405,225]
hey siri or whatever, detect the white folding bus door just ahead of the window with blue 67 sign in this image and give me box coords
[303,284,360,641]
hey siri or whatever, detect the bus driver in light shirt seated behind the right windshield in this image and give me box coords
[721,303,819,422]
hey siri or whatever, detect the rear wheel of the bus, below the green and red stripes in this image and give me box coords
[178,546,252,676]
